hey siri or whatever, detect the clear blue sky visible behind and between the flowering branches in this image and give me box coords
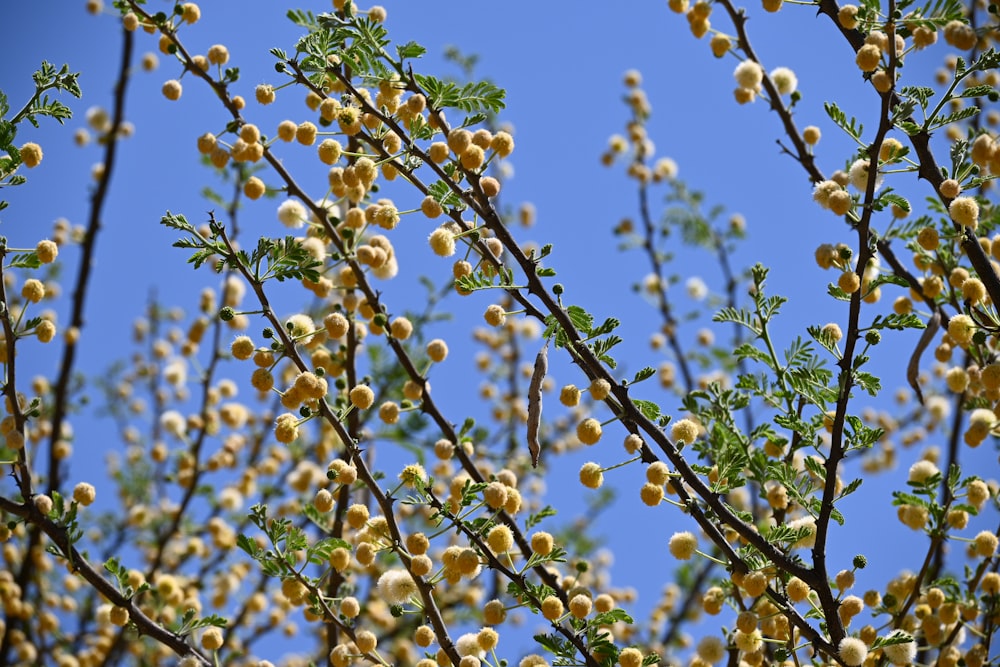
[0,0,996,664]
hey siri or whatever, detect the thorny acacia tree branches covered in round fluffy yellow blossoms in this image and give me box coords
[0,0,1000,667]
